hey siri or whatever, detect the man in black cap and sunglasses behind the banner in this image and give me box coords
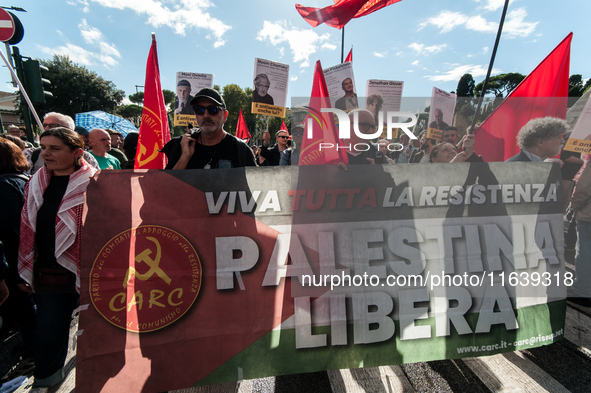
[162,88,256,169]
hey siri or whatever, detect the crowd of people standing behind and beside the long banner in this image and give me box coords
[0,85,591,392]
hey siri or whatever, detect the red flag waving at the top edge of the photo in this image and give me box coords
[296,0,400,29]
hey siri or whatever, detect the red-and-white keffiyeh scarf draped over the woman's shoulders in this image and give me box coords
[18,160,96,292]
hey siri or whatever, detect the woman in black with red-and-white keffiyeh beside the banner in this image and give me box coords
[18,127,96,392]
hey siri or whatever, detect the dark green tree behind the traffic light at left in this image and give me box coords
[30,55,125,118]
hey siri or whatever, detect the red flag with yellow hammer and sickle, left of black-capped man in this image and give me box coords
[134,35,170,169]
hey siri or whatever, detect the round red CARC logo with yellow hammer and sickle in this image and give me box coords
[89,225,202,333]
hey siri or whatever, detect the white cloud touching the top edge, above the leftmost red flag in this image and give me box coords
[92,0,232,48]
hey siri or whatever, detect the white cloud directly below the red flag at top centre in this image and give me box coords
[256,20,336,68]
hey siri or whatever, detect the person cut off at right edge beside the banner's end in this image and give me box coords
[568,158,591,307]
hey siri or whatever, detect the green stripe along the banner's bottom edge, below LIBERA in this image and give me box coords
[196,301,566,386]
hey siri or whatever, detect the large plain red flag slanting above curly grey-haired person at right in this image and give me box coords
[474,33,573,162]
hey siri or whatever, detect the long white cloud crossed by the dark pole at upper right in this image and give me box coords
[419,8,539,38]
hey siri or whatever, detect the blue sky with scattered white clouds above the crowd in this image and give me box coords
[0,0,591,107]
